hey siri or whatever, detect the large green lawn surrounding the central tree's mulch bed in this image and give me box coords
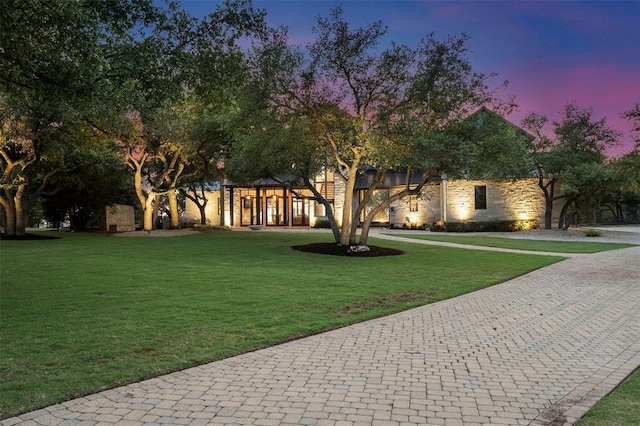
[0,232,561,417]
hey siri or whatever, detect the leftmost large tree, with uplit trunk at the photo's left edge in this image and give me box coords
[0,0,182,234]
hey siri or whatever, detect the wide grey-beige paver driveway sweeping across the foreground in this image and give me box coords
[5,236,640,426]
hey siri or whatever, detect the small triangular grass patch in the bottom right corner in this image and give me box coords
[576,370,640,426]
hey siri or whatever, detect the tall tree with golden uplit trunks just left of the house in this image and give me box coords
[116,0,264,230]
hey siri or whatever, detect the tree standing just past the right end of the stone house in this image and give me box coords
[522,103,621,229]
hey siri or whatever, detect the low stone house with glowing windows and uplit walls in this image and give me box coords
[186,108,559,228]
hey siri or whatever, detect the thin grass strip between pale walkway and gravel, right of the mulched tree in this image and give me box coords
[390,233,635,253]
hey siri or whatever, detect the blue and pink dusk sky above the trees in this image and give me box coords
[182,0,640,156]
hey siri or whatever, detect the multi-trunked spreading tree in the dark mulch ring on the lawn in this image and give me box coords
[231,8,512,245]
